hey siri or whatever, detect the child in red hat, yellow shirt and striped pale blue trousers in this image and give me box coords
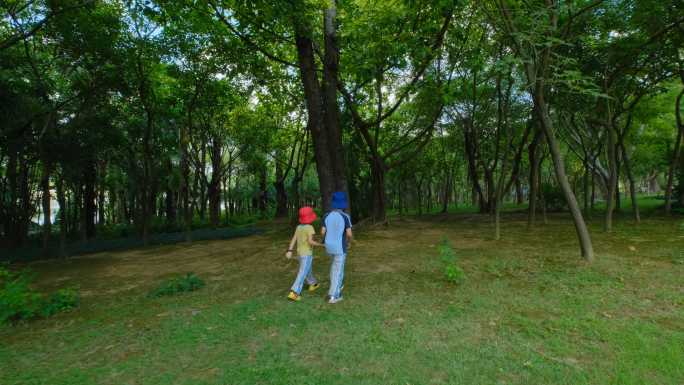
[285,206,323,301]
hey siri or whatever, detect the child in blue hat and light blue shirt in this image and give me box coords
[321,191,352,303]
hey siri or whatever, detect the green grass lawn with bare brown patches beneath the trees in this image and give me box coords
[0,208,684,385]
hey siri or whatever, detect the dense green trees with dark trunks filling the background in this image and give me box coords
[0,0,684,260]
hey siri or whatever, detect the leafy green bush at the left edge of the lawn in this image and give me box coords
[0,266,79,325]
